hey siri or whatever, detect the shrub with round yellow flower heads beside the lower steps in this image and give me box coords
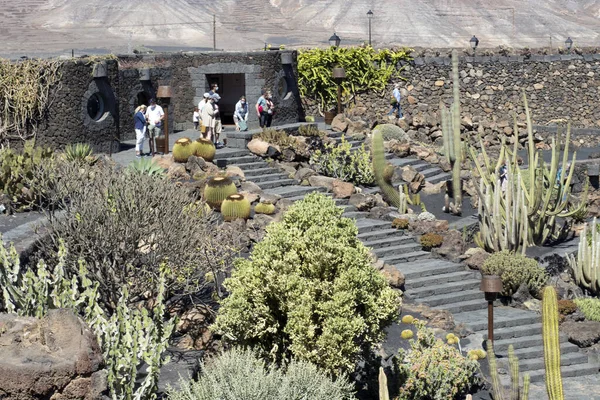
[398,321,479,400]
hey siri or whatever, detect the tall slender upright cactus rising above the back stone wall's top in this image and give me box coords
[440,50,464,215]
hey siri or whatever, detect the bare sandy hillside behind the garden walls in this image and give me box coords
[0,0,600,54]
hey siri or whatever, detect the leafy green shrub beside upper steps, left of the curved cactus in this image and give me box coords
[310,136,375,185]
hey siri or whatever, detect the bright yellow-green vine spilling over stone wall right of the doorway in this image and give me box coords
[298,46,412,111]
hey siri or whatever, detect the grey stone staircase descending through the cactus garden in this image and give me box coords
[216,141,599,383]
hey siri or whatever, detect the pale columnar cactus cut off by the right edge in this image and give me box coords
[567,218,600,295]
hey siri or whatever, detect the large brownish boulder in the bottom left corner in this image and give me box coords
[0,309,108,400]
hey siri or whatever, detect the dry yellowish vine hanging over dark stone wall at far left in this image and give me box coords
[0,59,63,143]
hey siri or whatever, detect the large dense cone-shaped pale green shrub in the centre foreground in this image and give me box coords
[213,193,400,374]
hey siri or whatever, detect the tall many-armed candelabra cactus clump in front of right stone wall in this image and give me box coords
[469,94,587,251]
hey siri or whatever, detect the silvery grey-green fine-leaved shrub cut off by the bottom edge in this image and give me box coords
[168,348,354,400]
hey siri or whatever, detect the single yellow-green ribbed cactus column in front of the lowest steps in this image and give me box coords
[542,286,564,400]
